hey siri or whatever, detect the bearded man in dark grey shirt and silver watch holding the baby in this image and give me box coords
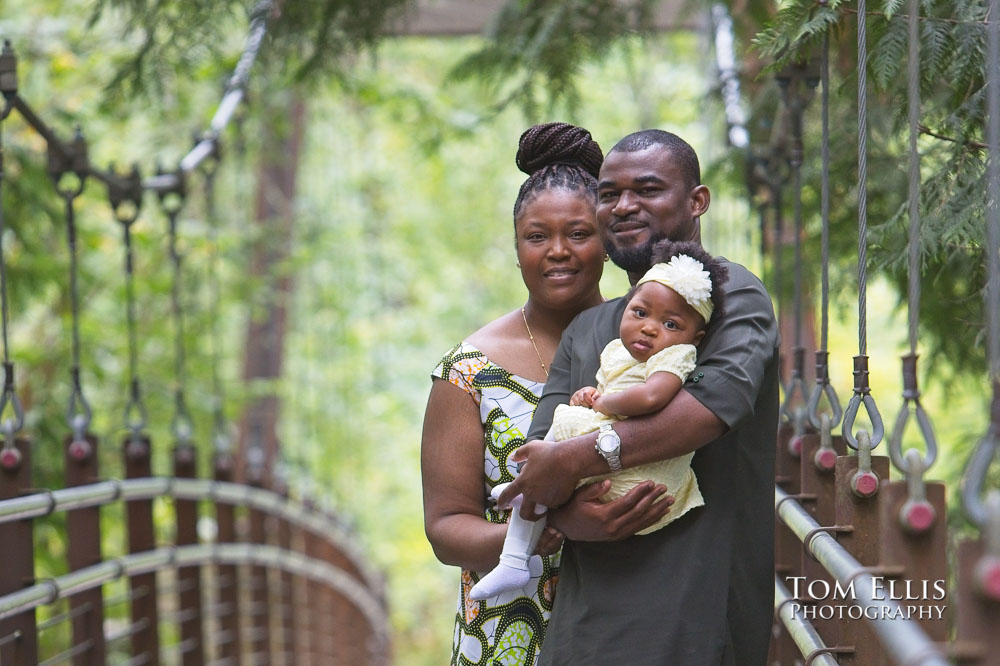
[500,130,778,666]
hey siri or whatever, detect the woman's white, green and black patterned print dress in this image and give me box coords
[431,342,559,666]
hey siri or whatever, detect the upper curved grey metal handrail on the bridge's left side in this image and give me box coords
[0,476,383,590]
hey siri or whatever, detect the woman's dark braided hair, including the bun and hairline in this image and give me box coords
[514,123,604,220]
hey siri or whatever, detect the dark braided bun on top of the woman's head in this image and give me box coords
[515,123,604,178]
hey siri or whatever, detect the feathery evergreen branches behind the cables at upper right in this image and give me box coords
[756,1,986,377]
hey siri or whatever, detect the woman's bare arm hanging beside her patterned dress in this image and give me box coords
[420,379,507,571]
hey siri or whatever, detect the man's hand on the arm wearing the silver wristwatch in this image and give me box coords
[497,440,580,520]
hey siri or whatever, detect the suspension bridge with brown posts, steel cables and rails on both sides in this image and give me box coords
[0,2,1000,666]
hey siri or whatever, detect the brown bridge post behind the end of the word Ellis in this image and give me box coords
[879,481,950,643]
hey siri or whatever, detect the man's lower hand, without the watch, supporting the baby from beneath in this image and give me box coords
[548,479,674,541]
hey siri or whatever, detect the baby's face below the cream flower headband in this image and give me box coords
[619,282,705,362]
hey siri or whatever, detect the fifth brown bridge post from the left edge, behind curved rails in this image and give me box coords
[213,453,243,666]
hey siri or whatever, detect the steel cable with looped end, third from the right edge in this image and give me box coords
[841,0,884,450]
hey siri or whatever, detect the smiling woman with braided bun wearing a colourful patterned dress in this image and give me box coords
[421,123,607,665]
